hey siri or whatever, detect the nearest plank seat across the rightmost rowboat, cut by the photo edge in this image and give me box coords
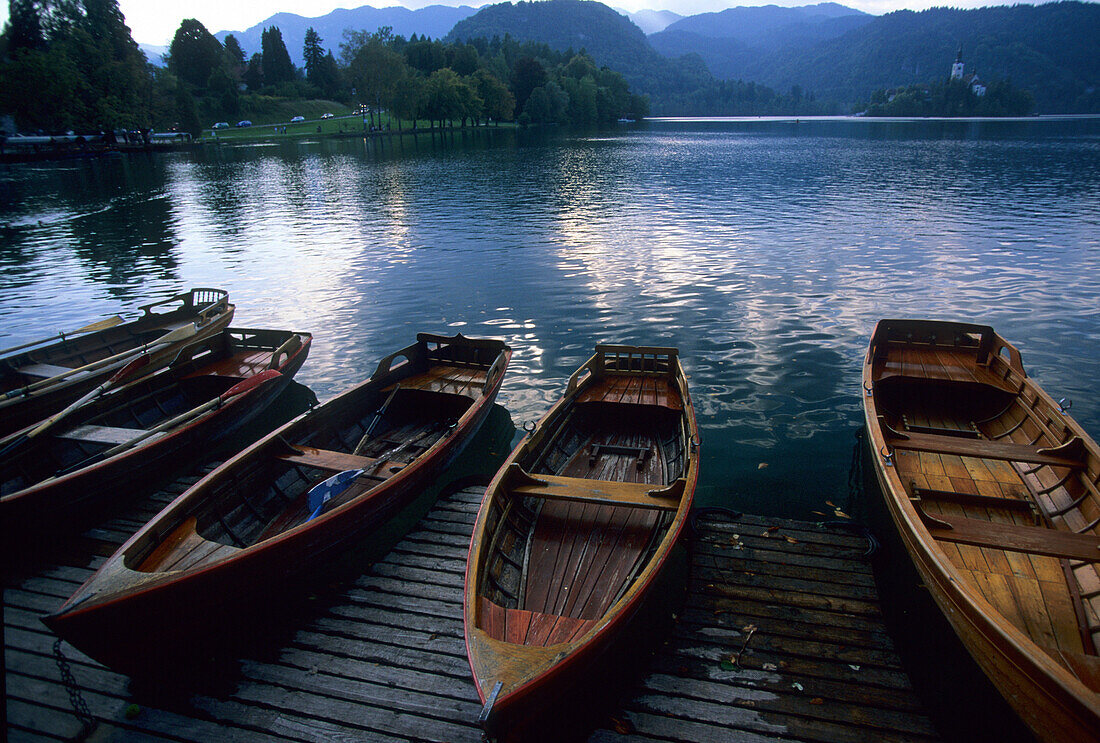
[926,513,1100,561]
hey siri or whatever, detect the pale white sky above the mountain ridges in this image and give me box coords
[0,0,1064,45]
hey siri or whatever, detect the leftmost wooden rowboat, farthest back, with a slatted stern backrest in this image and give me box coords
[0,288,234,436]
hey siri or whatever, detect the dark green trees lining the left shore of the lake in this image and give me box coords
[0,0,648,135]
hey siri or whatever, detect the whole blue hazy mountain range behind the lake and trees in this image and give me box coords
[200,0,1100,113]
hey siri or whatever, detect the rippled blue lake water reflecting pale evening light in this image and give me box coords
[0,119,1100,518]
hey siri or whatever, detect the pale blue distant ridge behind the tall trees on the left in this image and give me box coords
[215,6,477,67]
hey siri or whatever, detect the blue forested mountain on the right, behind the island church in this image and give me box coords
[653,2,1100,113]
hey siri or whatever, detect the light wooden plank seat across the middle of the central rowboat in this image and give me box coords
[508,463,685,511]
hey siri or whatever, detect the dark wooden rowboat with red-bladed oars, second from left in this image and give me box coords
[0,329,311,532]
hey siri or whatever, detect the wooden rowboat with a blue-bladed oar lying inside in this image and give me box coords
[44,334,512,674]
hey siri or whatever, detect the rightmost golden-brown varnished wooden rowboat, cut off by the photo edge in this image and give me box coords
[864,320,1100,742]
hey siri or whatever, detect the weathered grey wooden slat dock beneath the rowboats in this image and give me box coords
[3,473,937,743]
